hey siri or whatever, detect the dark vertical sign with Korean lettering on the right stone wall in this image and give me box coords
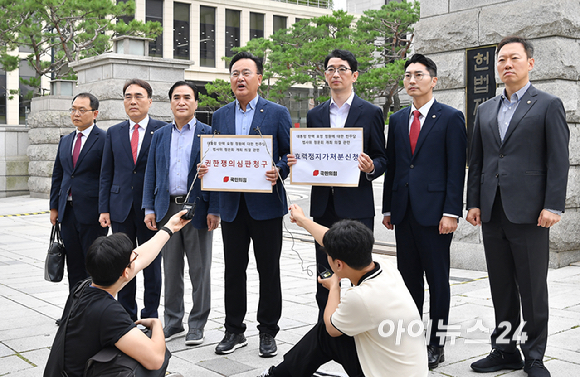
[465,45,497,144]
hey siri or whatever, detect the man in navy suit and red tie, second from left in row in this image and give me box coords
[99,79,166,321]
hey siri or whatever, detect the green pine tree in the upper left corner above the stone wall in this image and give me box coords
[0,0,162,94]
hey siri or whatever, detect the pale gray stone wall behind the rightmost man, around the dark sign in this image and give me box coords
[415,0,580,270]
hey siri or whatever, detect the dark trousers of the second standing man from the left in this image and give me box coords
[111,204,161,321]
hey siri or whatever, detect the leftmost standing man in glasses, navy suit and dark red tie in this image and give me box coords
[50,93,107,290]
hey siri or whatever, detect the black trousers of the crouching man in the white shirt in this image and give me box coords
[272,322,364,377]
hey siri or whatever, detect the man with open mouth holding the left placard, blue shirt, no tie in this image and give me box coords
[205,52,292,357]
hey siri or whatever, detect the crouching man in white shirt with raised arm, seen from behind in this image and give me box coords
[262,204,429,377]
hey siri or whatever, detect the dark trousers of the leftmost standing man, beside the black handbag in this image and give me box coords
[60,201,109,291]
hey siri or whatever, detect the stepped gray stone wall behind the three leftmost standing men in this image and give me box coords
[27,53,192,198]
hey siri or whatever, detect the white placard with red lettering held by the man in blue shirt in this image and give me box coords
[200,135,272,192]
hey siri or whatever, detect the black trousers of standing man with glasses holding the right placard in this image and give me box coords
[313,193,375,321]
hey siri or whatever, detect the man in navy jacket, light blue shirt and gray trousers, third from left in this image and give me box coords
[142,81,219,346]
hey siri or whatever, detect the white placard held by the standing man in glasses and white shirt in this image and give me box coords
[290,127,363,187]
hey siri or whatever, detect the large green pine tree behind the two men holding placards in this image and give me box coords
[200,4,419,114]
